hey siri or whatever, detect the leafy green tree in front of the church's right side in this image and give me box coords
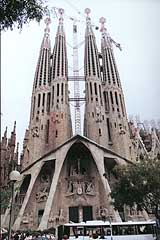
[111,158,160,221]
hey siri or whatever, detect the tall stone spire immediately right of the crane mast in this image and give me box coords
[84,8,107,147]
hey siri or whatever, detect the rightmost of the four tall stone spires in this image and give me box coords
[100,17,134,159]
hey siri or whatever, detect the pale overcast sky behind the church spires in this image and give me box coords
[1,0,160,152]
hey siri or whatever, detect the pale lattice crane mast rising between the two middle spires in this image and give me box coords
[73,21,81,134]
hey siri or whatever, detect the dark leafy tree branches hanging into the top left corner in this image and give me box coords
[0,0,47,30]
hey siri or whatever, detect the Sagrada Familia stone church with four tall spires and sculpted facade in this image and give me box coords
[1,10,160,230]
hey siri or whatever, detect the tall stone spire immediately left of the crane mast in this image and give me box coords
[48,9,72,149]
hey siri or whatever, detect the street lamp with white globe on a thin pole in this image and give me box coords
[8,170,21,240]
